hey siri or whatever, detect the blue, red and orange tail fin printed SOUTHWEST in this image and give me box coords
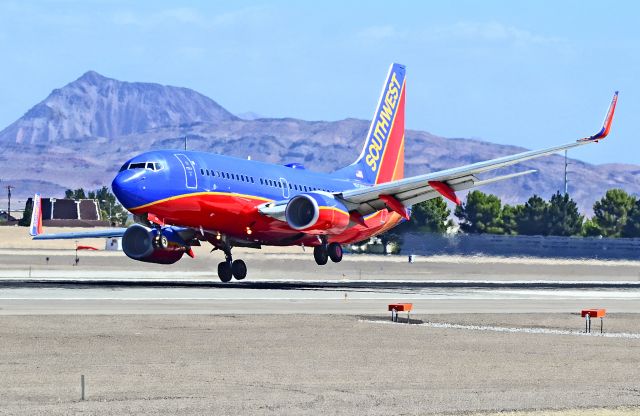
[336,63,406,184]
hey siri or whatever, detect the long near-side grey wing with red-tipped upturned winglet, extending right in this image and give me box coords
[336,91,618,218]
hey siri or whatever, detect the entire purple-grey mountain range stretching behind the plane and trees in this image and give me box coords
[0,71,640,212]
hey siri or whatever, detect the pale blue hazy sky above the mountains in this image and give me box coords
[0,0,640,163]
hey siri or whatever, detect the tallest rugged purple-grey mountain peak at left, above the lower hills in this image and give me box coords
[0,71,236,144]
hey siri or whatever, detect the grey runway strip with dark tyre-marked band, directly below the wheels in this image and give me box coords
[0,278,640,315]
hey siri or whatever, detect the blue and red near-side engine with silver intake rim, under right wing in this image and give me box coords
[285,192,349,234]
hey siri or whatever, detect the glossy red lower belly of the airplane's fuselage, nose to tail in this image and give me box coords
[131,193,401,246]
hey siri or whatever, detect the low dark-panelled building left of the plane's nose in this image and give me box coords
[25,198,109,227]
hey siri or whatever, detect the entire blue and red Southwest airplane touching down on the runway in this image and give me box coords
[30,64,618,282]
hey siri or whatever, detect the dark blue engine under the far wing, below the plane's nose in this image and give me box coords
[122,224,189,264]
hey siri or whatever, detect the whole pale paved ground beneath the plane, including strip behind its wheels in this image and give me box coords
[0,249,640,315]
